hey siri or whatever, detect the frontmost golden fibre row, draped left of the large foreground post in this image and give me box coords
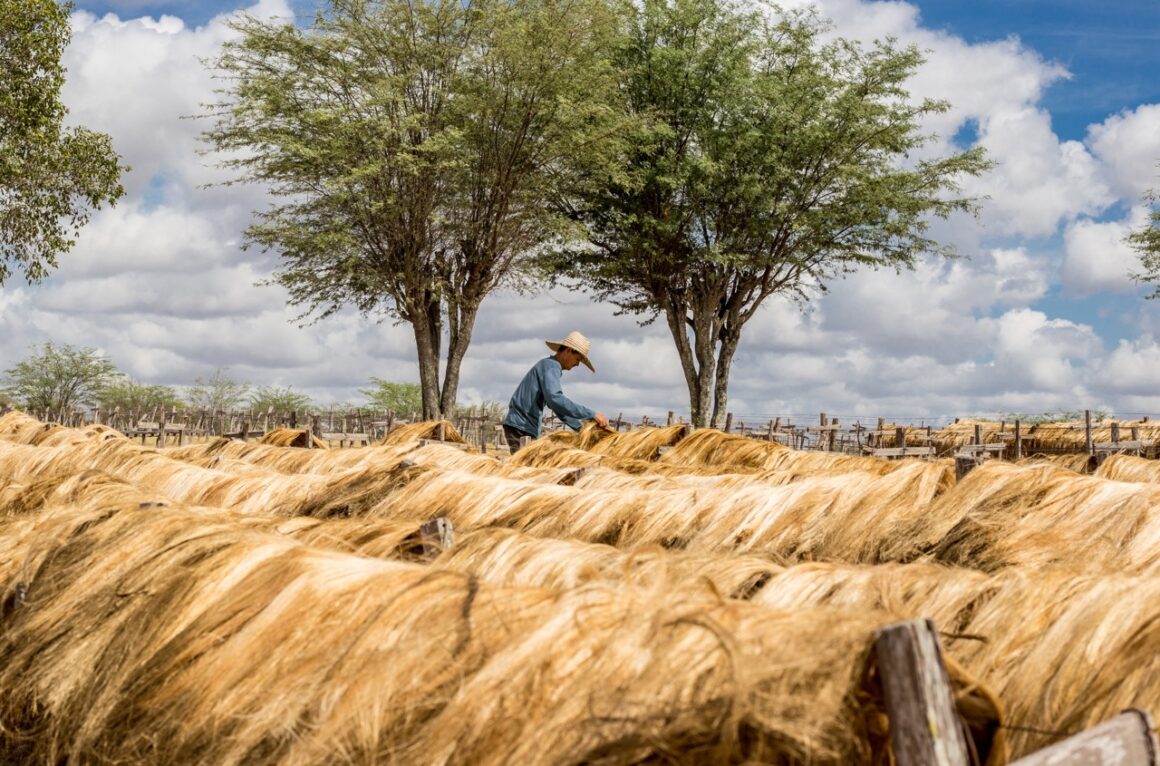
[0,496,995,764]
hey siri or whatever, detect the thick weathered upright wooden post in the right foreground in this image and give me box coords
[875,620,971,766]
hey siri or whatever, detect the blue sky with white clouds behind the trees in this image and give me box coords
[0,0,1160,421]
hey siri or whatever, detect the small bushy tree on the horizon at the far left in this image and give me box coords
[5,341,121,417]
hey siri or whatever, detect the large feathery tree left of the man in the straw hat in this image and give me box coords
[204,0,621,418]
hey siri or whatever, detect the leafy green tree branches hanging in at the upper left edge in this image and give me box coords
[0,0,128,284]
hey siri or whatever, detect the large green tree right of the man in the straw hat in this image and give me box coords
[545,0,987,426]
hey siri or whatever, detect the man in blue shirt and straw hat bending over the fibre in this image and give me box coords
[503,331,608,455]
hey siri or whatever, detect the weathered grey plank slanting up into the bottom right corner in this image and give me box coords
[1010,708,1160,766]
